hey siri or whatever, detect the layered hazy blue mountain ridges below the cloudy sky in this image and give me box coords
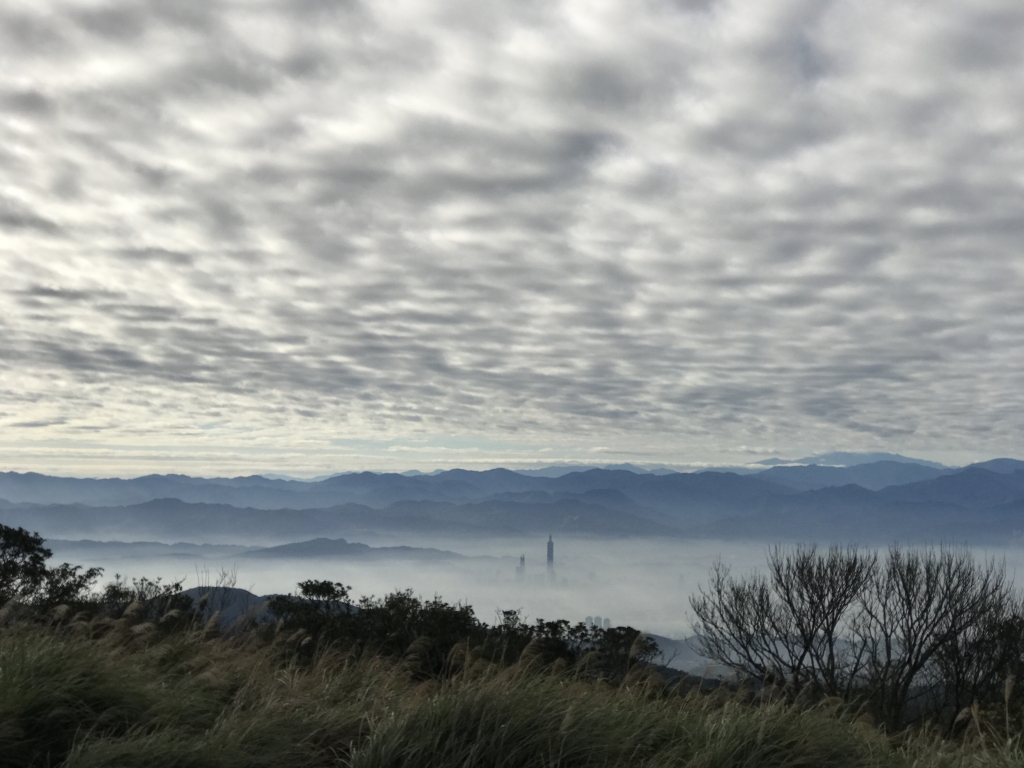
[6,455,1024,545]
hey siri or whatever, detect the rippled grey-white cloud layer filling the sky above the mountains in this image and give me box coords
[0,0,1024,473]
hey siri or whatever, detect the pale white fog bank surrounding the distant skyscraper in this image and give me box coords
[49,538,1024,638]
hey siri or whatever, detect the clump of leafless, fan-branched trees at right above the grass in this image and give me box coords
[690,546,1024,729]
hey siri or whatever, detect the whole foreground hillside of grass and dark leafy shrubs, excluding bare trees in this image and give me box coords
[0,528,1024,768]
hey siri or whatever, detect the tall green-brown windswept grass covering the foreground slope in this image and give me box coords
[6,620,1024,768]
